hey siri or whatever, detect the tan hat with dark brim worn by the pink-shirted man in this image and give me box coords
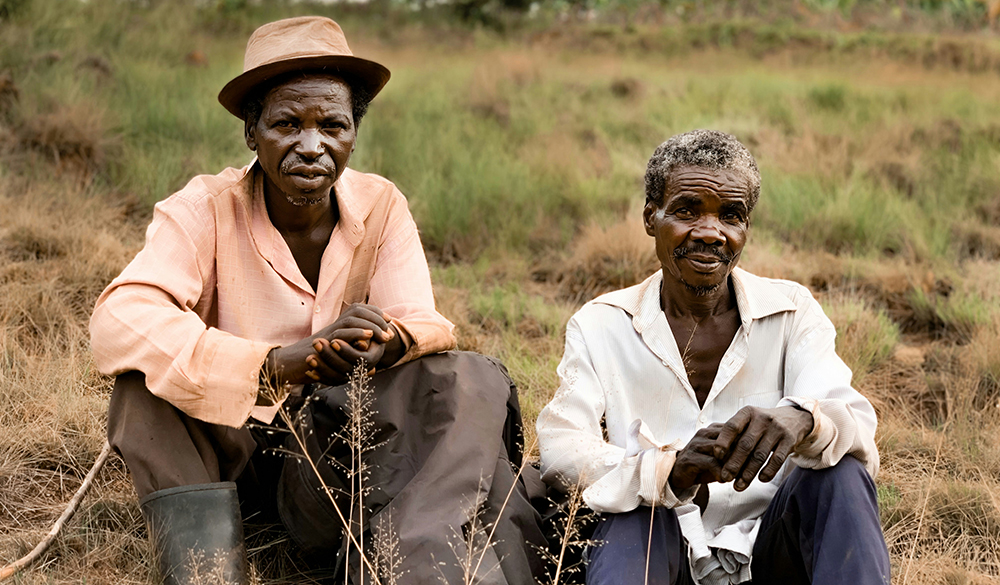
[219,16,389,120]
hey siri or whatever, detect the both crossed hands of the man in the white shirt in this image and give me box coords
[668,406,813,494]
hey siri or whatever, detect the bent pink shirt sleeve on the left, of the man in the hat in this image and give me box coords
[90,198,274,427]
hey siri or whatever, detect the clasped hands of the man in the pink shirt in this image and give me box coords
[306,303,403,384]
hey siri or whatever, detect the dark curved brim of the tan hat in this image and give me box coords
[219,55,389,120]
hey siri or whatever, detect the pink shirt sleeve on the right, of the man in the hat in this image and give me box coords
[370,187,455,363]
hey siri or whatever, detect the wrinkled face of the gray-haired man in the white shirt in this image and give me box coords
[642,167,750,295]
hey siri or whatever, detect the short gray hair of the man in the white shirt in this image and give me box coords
[646,130,760,211]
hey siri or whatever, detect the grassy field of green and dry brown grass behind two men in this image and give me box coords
[0,0,1000,585]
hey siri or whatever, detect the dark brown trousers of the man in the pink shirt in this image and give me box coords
[108,352,546,585]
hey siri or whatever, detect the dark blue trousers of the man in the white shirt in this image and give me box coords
[587,457,890,585]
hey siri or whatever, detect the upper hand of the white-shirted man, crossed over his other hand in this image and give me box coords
[715,406,813,491]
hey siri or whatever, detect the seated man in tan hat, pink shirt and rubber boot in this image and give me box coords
[90,17,541,584]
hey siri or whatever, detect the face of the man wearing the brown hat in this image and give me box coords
[246,75,357,206]
